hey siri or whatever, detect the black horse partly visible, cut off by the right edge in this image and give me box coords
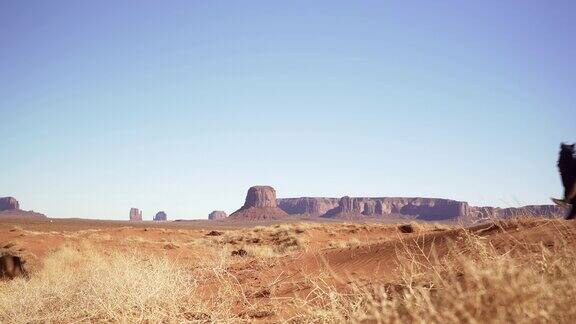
[558,143,576,219]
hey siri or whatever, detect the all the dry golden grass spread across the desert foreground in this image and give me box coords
[0,219,576,323]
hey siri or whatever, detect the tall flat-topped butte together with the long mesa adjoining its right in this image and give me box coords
[228,186,566,221]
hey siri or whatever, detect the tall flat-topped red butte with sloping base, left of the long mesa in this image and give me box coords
[228,186,288,221]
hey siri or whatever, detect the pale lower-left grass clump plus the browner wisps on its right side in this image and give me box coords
[0,246,245,323]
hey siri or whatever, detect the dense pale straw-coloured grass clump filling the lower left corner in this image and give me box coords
[0,248,197,322]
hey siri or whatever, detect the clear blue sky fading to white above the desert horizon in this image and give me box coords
[0,0,576,219]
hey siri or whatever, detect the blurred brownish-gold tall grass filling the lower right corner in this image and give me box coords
[290,221,576,323]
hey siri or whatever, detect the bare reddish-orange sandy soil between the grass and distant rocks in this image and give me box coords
[0,219,576,320]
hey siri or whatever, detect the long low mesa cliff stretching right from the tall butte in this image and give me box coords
[278,196,565,220]
